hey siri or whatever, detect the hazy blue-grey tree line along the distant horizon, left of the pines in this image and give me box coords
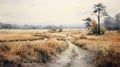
[0,22,84,31]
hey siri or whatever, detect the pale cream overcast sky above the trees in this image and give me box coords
[0,0,120,24]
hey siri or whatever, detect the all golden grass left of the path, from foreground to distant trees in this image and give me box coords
[0,30,67,63]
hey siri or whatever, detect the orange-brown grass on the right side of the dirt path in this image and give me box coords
[71,32,120,67]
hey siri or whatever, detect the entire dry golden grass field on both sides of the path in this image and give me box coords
[0,30,120,67]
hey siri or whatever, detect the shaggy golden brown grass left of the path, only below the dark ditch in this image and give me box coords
[0,40,67,62]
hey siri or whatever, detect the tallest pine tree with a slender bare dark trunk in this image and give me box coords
[93,3,108,34]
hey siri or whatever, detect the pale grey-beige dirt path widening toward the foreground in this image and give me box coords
[22,40,93,67]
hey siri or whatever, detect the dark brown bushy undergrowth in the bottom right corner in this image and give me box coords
[95,44,120,67]
